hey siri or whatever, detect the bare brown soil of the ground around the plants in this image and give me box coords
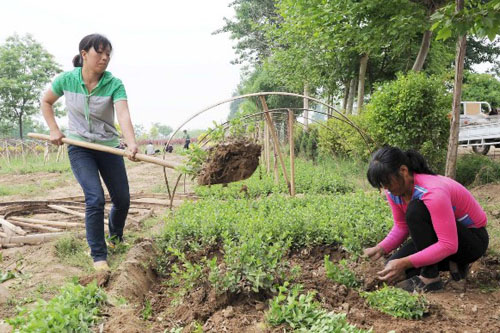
[0,155,500,333]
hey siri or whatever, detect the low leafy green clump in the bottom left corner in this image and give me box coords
[6,282,106,332]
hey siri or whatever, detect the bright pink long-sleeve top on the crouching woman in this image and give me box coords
[378,173,487,268]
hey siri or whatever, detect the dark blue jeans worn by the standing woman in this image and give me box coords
[68,145,130,261]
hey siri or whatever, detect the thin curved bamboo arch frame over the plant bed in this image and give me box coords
[163,92,373,205]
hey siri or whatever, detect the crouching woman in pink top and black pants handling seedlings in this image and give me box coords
[364,146,488,292]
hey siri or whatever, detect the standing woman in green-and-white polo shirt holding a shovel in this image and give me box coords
[41,34,138,270]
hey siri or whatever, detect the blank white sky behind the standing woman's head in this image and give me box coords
[0,0,240,129]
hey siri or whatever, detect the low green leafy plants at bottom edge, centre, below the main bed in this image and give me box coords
[266,282,371,333]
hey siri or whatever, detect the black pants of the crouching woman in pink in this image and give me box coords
[388,199,489,278]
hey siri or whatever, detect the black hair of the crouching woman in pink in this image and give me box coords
[366,146,435,188]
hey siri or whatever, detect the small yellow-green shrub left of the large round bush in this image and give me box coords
[318,113,373,160]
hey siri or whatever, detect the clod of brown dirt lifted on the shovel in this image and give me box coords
[198,139,262,185]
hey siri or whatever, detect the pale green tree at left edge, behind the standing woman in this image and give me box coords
[0,35,61,139]
